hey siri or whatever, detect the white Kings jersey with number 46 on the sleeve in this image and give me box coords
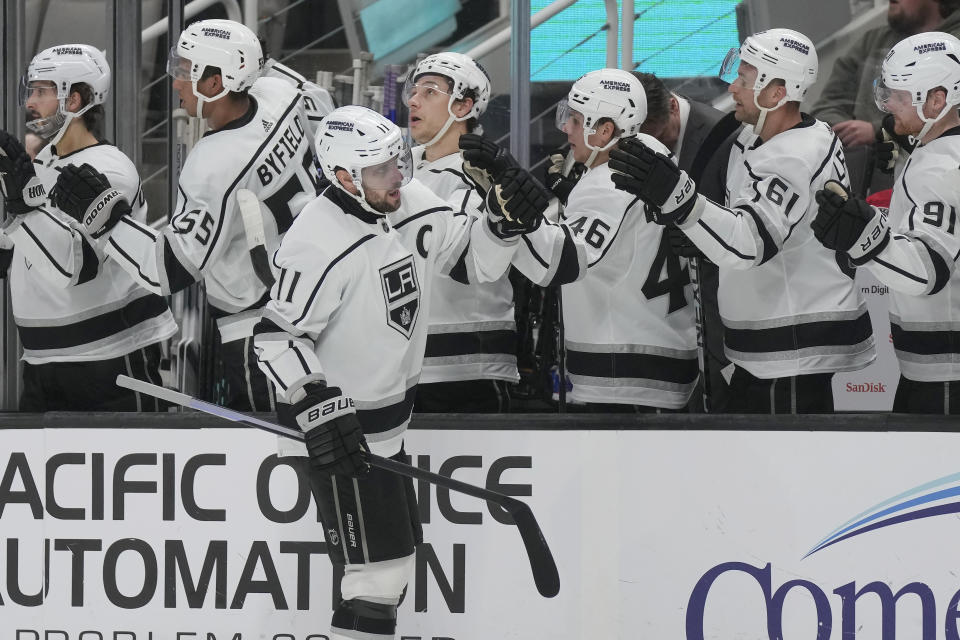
[514,134,698,409]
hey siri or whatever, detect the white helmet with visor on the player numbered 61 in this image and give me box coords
[720,29,820,135]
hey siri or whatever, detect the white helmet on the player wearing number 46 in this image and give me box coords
[556,69,647,166]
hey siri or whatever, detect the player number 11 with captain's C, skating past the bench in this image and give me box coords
[249,106,548,640]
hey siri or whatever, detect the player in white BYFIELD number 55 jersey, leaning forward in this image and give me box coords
[51,20,319,411]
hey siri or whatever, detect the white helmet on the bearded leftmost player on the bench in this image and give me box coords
[19,44,110,144]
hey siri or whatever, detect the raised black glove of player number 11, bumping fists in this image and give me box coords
[487,167,550,238]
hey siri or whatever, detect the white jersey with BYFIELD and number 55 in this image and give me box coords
[105,78,319,342]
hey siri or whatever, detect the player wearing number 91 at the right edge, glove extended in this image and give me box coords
[813,32,960,414]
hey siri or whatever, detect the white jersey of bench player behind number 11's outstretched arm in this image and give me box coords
[413,146,519,383]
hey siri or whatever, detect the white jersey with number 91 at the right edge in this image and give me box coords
[867,128,960,382]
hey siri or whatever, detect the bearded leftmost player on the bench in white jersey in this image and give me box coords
[0,44,176,411]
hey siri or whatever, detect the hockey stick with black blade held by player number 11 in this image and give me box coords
[117,375,560,598]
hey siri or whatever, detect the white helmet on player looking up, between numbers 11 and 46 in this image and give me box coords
[402,51,490,146]
